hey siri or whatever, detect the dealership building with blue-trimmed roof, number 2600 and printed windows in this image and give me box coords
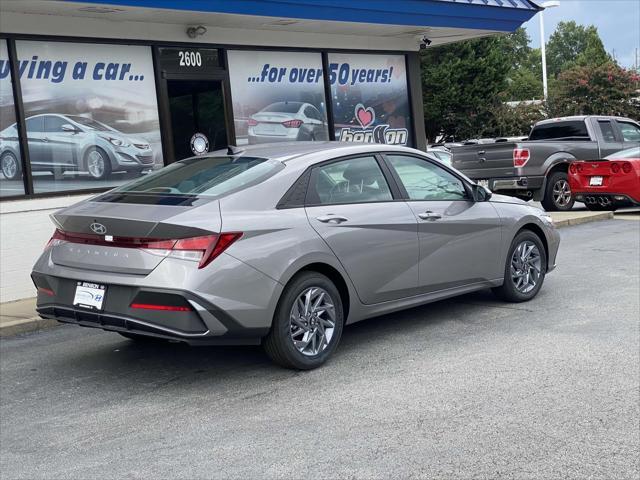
[0,0,540,302]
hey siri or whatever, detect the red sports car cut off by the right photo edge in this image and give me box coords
[569,146,640,210]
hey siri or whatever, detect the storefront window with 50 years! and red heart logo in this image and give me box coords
[328,53,413,145]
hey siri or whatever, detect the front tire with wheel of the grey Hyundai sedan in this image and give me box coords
[492,230,547,303]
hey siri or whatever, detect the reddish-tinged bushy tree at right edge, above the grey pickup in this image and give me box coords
[548,62,640,119]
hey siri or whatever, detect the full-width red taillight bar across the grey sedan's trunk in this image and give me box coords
[45,229,242,268]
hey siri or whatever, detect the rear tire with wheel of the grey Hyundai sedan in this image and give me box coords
[263,272,344,370]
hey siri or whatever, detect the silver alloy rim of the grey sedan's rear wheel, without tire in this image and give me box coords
[289,287,336,356]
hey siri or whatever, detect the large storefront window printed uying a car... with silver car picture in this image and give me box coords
[16,41,163,193]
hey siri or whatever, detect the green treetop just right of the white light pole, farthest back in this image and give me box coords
[547,21,613,78]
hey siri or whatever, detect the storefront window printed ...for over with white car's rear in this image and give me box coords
[228,51,329,145]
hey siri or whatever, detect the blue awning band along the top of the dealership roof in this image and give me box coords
[69,0,540,32]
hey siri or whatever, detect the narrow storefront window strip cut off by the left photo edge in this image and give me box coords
[0,39,24,197]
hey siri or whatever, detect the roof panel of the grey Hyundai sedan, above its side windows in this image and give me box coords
[210,141,424,162]
